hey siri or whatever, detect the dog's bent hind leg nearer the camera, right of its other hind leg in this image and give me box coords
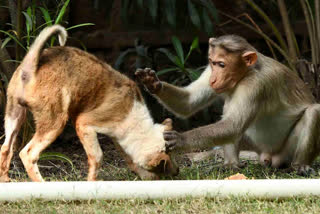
[19,113,68,182]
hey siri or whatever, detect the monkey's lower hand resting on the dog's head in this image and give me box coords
[163,131,185,151]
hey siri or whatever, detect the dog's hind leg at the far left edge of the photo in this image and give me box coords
[0,97,26,182]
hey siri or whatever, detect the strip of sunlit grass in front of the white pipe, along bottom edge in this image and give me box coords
[0,197,320,214]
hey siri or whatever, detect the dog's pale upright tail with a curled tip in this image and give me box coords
[21,25,68,74]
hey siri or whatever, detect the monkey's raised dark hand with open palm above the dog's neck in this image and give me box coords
[135,68,162,94]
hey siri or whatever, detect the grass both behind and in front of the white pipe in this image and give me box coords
[0,145,320,214]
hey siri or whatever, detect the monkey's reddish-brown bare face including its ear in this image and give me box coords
[208,46,256,93]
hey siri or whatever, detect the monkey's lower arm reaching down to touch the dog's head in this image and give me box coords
[164,89,259,152]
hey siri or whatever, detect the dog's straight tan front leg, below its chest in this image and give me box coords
[75,118,103,181]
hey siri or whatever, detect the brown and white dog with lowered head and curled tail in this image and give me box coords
[0,25,178,181]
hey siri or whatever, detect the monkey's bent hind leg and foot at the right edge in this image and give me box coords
[283,104,320,175]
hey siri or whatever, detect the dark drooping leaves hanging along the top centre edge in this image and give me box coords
[117,0,219,35]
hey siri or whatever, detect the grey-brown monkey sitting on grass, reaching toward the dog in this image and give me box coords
[135,35,320,175]
